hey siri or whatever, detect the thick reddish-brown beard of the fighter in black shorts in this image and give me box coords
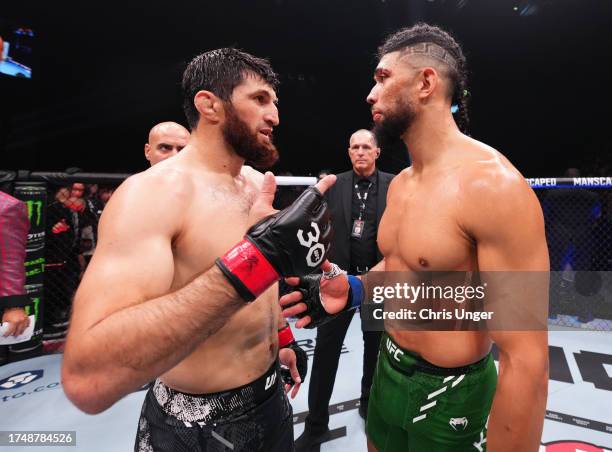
[222,102,278,168]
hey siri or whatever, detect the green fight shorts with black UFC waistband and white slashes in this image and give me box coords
[366,333,497,452]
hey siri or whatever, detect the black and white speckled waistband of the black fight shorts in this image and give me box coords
[152,361,281,427]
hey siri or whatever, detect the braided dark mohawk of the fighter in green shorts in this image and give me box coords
[378,23,469,133]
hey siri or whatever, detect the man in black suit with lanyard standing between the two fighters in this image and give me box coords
[295,129,393,452]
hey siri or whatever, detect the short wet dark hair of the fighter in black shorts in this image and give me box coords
[182,47,278,130]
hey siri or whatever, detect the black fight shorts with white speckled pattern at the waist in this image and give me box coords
[134,362,293,452]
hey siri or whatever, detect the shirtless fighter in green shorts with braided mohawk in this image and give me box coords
[281,24,549,452]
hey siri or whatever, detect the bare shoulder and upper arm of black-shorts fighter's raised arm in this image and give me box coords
[71,164,195,337]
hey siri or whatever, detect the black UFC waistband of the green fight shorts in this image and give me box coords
[380,332,490,376]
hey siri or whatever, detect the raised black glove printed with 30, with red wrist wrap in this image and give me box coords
[215,187,333,301]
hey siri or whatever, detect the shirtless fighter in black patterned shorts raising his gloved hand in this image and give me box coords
[62,48,335,452]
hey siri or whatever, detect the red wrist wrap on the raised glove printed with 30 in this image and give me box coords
[220,239,280,298]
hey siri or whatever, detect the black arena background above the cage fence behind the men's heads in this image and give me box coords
[0,0,612,176]
